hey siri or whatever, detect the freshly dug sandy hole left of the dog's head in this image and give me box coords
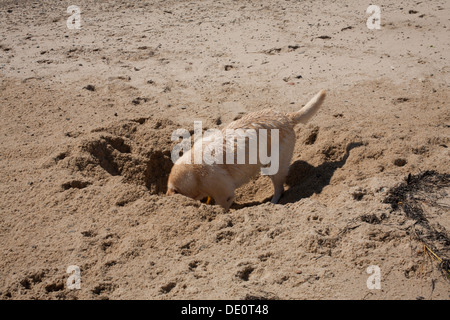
[58,119,176,194]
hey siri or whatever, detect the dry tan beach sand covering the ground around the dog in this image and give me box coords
[0,0,450,299]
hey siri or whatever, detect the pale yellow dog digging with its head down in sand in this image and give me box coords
[167,90,326,210]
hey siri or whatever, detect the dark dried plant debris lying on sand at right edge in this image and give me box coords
[384,171,450,279]
